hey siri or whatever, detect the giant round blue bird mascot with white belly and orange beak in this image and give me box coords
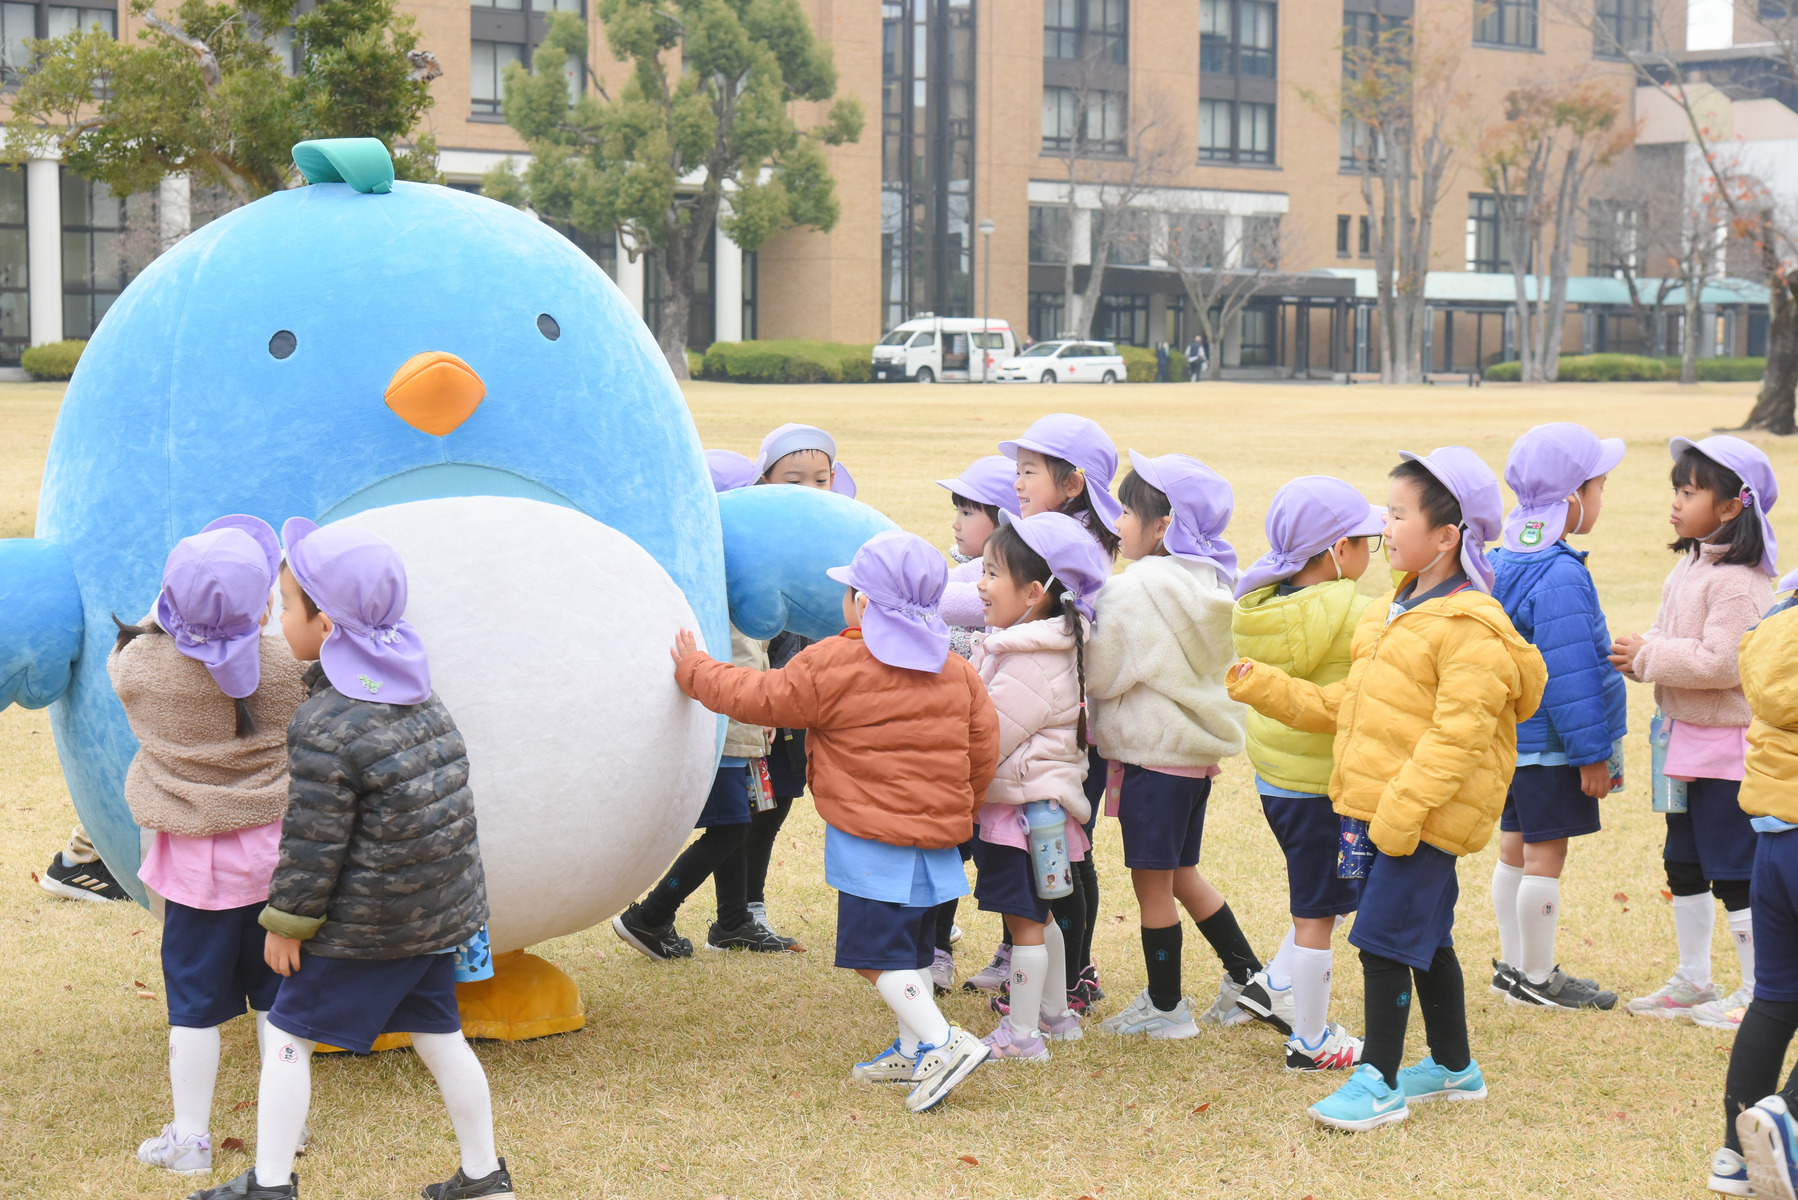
[0,139,892,1038]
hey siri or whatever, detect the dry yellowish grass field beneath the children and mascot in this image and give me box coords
[0,383,1798,1200]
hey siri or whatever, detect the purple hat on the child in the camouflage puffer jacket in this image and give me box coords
[280,516,432,703]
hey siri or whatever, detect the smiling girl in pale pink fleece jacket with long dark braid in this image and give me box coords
[973,513,1109,1061]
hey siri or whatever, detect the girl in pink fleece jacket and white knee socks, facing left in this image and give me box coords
[1611,435,1780,1031]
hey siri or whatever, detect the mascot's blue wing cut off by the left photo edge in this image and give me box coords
[0,538,85,709]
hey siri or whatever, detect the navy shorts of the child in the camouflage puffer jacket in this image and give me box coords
[268,948,462,1054]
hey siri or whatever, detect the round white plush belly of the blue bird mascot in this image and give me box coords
[343,497,717,952]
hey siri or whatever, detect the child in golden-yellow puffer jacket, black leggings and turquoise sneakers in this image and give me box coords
[1228,446,1548,1130]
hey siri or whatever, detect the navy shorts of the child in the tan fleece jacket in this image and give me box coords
[162,900,280,1029]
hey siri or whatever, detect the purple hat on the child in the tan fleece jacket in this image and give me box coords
[156,515,280,700]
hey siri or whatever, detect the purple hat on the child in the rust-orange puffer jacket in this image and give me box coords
[825,529,949,675]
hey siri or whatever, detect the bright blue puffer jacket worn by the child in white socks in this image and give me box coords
[1492,542,1629,766]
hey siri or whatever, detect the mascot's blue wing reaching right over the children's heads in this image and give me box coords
[717,484,897,640]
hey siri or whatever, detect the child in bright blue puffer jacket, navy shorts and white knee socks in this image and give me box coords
[1492,421,1627,1009]
